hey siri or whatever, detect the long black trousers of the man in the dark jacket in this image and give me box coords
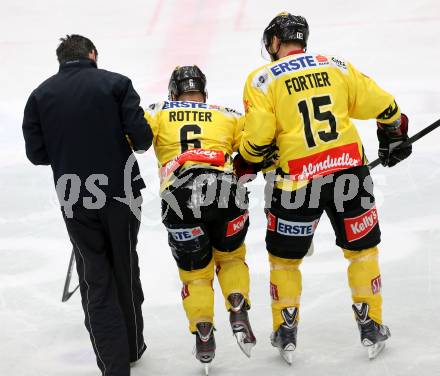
[63,198,146,376]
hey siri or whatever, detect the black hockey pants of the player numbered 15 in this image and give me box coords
[266,166,381,259]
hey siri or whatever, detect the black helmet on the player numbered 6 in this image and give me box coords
[168,65,208,100]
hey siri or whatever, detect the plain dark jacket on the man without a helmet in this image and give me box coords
[23,59,153,197]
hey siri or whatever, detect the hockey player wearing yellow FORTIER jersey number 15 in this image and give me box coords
[236,13,411,363]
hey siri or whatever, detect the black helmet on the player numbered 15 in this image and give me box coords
[263,12,309,60]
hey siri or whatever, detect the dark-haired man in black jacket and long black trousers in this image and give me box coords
[23,35,153,376]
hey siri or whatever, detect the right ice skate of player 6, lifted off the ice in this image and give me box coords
[228,293,257,358]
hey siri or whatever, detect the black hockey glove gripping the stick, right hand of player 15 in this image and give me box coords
[377,114,412,167]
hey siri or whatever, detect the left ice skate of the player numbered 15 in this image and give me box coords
[270,307,298,365]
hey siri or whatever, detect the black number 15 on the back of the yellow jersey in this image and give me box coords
[298,95,339,148]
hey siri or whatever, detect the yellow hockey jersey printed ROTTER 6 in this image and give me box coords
[145,101,244,190]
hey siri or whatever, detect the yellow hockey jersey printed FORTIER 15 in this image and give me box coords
[240,51,400,190]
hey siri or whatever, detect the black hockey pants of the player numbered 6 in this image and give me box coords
[162,169,249,271]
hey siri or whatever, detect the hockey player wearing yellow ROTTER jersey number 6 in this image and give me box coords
[146,66,256,370]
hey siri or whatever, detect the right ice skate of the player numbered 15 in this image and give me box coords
[352,303,391,359]
